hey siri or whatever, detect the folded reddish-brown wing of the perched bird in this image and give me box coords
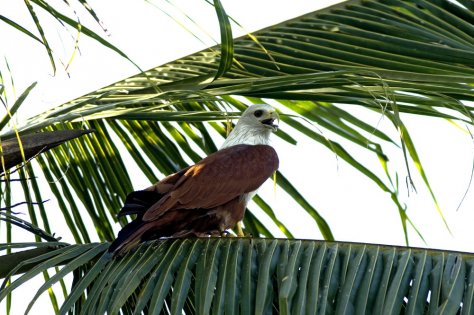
[143,144,278,221]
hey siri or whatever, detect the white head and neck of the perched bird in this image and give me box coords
[221,104,280,149]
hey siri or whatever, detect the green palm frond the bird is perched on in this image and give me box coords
[0,238,474,314]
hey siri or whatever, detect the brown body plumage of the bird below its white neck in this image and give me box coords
[109,144,279,254]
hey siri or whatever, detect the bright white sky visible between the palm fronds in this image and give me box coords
[0,0,474,314]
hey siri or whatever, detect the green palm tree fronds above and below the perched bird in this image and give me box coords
[0,0,474,314]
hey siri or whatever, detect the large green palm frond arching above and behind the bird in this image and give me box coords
[3,1,474,246]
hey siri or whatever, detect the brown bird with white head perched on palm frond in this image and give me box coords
[109,104,279,256]
